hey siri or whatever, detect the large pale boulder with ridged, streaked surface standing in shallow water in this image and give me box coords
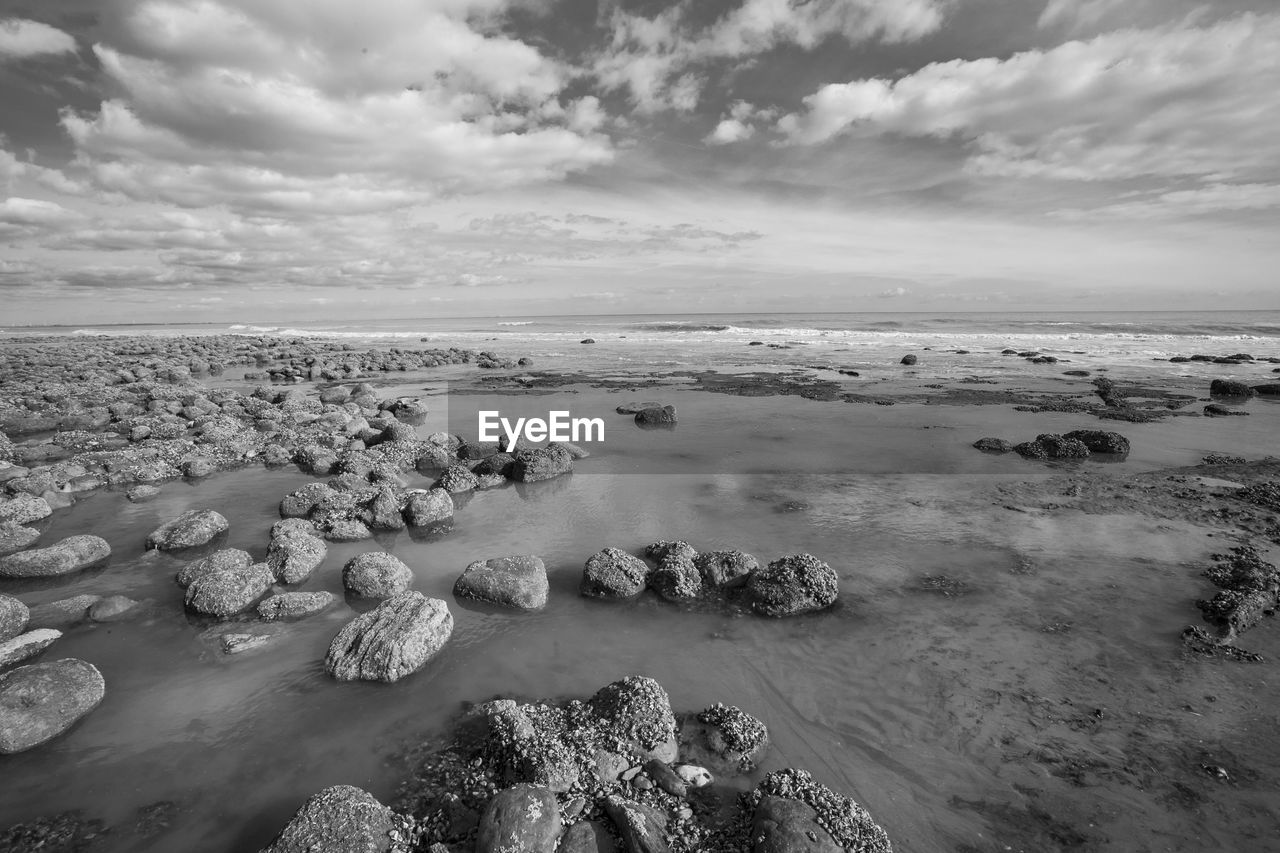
[325,592,453,681]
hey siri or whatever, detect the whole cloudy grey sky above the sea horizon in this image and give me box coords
[0,0,1280,325]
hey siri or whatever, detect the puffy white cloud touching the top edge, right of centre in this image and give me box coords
[593,0,948,113]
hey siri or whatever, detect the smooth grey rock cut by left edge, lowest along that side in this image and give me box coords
[0,658,106,754]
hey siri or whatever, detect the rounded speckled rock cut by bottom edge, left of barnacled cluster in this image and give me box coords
[262,785,396,853]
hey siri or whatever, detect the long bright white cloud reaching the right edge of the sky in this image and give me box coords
[778,14,1280,181]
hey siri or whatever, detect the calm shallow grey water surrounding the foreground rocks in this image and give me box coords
[0,380,1280,852]
